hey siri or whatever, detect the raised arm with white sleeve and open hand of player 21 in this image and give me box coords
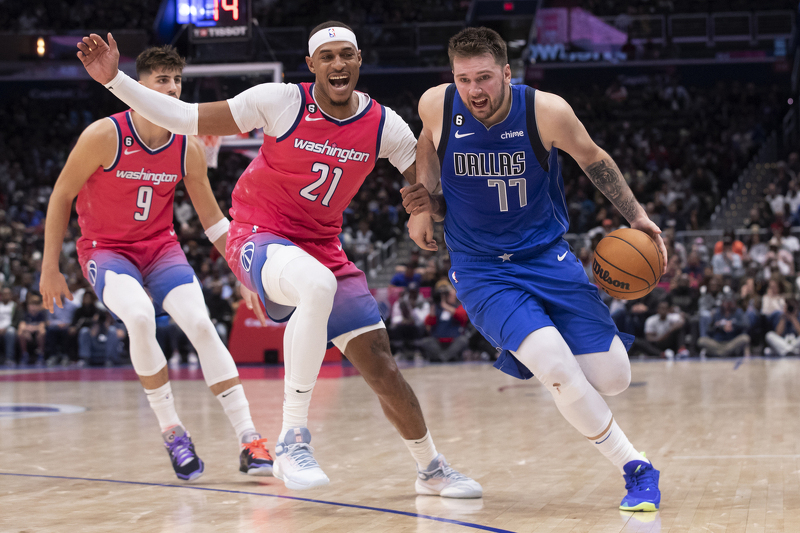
[78,33,245,135]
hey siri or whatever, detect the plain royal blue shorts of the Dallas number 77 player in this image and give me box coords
[450,239,633,379]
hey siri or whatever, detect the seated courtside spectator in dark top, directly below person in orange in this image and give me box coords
[697,294,750,357]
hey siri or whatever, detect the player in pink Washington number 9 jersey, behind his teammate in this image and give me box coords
[40,47,272,480]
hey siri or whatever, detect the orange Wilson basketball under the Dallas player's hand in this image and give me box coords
[592,228,664,300]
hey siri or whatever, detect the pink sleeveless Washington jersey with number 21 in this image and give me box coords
[228,83,385,247]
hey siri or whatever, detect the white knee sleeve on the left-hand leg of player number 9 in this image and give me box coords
[103,271,167,376]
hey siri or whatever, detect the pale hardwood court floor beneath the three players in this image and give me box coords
[0,358,800,533]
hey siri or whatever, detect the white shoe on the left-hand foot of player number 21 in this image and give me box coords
[272,428,330,490]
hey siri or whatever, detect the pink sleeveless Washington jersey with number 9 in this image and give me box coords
[77,111,188,248]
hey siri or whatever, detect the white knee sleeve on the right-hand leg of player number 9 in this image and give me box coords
[163,278,239,387]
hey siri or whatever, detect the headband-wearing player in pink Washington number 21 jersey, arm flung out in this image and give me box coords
[78,25,482,498]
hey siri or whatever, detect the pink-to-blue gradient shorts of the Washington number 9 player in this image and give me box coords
[81,241,195,318]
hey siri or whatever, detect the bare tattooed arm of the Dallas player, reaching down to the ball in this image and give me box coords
[536,91,667,274]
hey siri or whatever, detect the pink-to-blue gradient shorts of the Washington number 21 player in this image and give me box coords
[227,232,381,340]
